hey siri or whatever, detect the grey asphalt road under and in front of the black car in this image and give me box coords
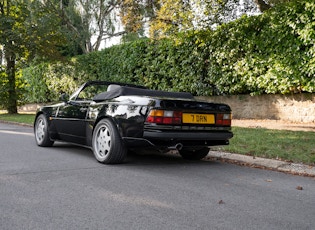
[0,124,315,230]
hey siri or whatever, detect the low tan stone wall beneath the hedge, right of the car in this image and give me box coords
[198,93,315,123]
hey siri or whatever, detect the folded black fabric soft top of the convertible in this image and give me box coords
[93,85,194,101]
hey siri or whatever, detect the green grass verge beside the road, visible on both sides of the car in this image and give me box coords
[0,114,315,165]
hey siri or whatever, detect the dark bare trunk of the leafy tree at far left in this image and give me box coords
[5,51,17,114]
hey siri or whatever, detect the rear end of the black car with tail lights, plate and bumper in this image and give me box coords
[143,99,233,150]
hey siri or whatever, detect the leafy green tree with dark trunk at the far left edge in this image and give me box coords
[0,0,63,114]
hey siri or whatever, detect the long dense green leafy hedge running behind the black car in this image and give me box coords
[23,1,315,102]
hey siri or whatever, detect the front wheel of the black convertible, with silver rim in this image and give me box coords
[34,114,54,147]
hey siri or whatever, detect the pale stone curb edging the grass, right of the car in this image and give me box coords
[207,151,315,177]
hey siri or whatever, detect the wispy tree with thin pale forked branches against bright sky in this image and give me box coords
[43,0,125,53]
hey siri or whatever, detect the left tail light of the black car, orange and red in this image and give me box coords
[146,109,182,125]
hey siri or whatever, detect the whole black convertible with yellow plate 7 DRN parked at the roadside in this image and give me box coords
[34,81,233,164]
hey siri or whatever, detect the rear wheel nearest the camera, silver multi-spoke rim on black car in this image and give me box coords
[92,119,127,164]
